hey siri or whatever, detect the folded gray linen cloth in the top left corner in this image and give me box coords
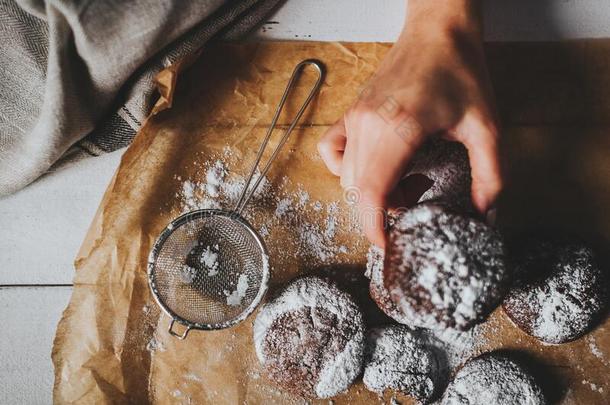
[0,0,279,196]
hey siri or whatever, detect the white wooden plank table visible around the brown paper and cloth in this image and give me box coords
[0,0,610,404]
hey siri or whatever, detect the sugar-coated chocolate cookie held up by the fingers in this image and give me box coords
[383,202,510,330]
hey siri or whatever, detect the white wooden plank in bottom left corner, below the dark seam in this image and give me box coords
[0,287,72,405]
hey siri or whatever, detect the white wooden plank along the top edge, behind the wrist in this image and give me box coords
[255,0,610,42]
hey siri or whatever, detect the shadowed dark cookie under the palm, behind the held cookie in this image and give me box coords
[406,138,473,211]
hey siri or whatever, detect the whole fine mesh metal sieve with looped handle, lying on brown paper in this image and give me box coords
[148,59,324,339]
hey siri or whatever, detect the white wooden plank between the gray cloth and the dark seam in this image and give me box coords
[0,150,123,285]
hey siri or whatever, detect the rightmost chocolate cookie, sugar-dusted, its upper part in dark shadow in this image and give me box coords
[502,238,607,343]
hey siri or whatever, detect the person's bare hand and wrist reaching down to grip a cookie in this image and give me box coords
[318,0,502,247]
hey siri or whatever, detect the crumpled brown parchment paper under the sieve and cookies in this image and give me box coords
[52,41,610,404]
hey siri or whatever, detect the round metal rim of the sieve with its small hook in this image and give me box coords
[147,209,271,332]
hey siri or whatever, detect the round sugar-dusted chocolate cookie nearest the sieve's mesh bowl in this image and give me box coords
[254,277,364,398]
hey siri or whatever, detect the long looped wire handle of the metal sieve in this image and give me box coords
[233,59,324,214]
